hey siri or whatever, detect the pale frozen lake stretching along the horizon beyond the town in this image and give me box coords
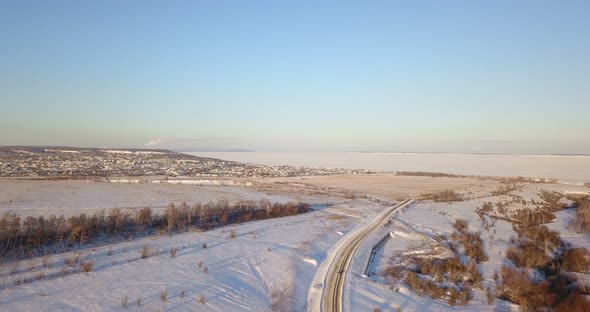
[188,152,590,182]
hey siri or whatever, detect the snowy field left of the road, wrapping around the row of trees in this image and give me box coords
[0,181,383,311]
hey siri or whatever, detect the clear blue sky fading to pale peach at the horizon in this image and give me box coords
[0,0,590,153]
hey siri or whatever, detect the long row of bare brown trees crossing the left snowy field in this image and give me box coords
[0,201,311,258]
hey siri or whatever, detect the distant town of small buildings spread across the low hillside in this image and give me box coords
[0,147,373,178]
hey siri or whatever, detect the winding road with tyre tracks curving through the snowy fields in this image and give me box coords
[322,199,414,312]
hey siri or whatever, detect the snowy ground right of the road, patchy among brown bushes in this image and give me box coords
[345,184,590,311]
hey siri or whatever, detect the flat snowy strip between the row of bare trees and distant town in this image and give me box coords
[0,180,299,217]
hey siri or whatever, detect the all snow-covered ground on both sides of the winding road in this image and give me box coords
[0,175,590,311]
